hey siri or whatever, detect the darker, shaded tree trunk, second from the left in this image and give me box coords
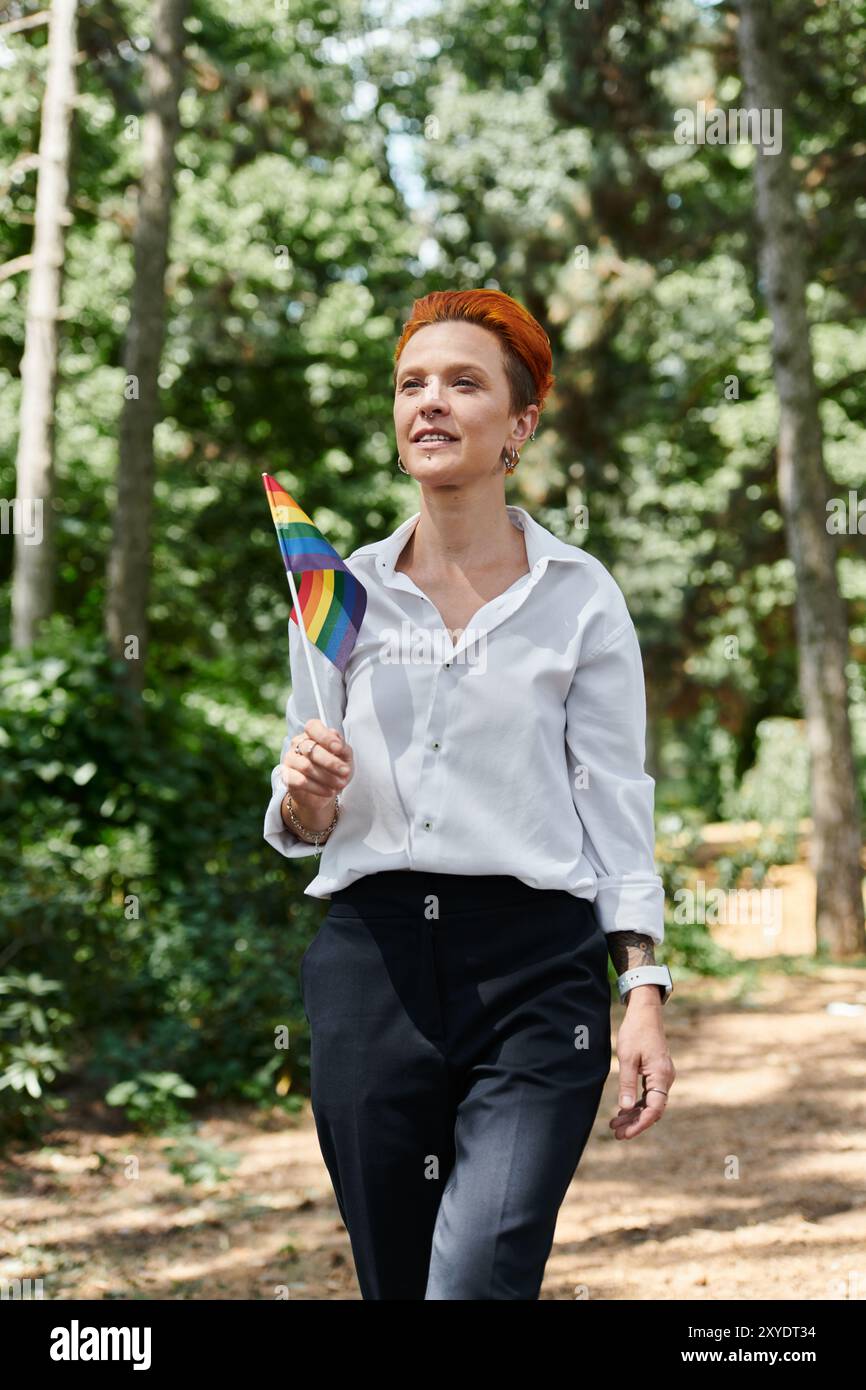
[106,0,186,692]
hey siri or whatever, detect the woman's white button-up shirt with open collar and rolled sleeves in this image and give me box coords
[264,506,664,942]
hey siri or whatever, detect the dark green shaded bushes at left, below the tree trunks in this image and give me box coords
[0,619,321,1137]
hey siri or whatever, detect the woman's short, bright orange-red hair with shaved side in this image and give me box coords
[393,289,556,416]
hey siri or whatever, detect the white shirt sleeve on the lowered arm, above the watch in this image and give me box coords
[566,607,664,944]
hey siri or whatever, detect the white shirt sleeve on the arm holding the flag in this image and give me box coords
[264,619,346,859]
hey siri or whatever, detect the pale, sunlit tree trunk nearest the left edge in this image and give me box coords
[13,0,76,648]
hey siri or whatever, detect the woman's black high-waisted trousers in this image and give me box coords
[300,870,612,1300]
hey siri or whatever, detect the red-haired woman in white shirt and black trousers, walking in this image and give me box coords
[264,289,674,1300]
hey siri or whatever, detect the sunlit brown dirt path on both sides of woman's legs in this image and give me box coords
[0,967,866,1301]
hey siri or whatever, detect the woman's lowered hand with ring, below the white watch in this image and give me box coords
[610,986,677,1138]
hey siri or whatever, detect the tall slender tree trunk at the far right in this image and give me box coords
[737,0,866,956]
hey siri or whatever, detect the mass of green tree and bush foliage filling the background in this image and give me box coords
[0,0,866,1134]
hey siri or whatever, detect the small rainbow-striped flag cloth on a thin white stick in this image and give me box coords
[261,473,367,671]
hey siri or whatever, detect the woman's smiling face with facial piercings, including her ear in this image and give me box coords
[393,320,538,485]
